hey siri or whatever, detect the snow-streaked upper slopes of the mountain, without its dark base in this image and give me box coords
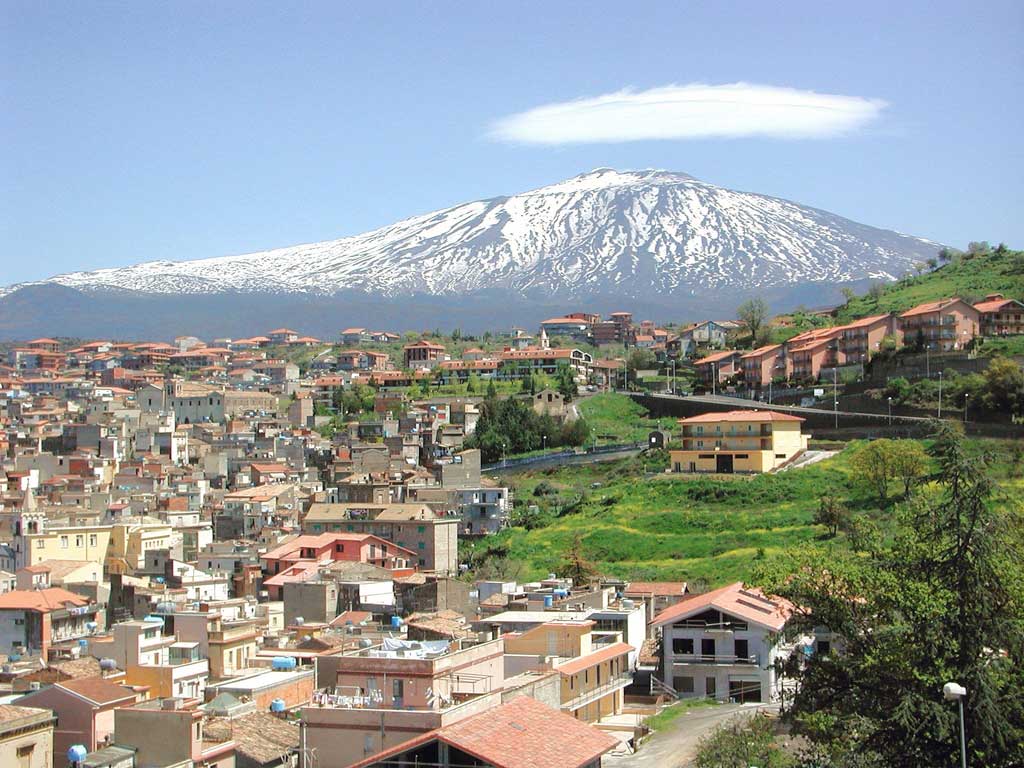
[4,169,938,299]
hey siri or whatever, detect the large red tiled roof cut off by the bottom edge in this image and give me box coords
[351,696,618,768]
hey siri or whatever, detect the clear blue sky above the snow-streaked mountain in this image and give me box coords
[0,0,1024,284]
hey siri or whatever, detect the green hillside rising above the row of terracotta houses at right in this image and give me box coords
[838,241,1024,323]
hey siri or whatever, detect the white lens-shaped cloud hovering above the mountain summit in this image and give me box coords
[488,83,887,144]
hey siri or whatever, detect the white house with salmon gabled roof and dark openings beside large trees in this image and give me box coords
[652,582,793,702]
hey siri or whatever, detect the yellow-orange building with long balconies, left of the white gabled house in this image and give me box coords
[505,620,633,723]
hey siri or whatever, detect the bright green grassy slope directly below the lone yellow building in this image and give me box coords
[467,440,1024,586]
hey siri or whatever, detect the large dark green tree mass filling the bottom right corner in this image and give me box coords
[756,423,1024,768]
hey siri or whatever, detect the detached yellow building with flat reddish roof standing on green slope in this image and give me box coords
[669,411,810,473]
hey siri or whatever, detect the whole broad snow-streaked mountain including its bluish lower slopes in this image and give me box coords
[0,168,939,334]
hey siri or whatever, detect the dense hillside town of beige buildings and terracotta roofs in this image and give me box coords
[0,246,1024,768]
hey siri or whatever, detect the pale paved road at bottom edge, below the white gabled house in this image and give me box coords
[602,705,777,768]
